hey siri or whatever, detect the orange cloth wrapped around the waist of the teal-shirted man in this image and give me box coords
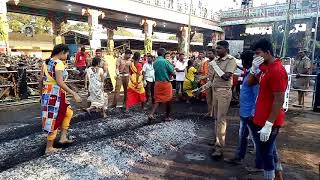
[154,81,172,103]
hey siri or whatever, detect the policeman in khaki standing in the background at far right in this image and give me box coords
[293,49,311,106]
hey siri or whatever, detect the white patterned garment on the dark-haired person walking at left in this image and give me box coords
[87,67,105,108]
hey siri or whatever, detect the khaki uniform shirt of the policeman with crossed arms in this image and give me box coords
[209,54,237,88]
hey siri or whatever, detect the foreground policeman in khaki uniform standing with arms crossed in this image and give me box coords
[209,41,237,158]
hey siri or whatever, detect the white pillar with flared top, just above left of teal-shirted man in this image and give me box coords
[141,19,156,54]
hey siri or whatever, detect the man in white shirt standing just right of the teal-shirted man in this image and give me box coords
[175,53,188,97]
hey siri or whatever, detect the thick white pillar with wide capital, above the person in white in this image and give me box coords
[82,8,104,51]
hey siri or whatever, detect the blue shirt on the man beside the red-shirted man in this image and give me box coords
[240,73,259,118]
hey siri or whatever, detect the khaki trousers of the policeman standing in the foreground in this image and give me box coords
[212,88,232,151]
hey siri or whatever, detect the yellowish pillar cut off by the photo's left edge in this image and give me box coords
[0,0,9,53]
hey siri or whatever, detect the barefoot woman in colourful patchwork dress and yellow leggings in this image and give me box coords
[39,44,81,154]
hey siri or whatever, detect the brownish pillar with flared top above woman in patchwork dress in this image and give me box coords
[47,15,67,45]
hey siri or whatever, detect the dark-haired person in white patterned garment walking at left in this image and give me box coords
[85,57,108,118]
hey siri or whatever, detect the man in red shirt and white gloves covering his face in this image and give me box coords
[249,39,288,180]
